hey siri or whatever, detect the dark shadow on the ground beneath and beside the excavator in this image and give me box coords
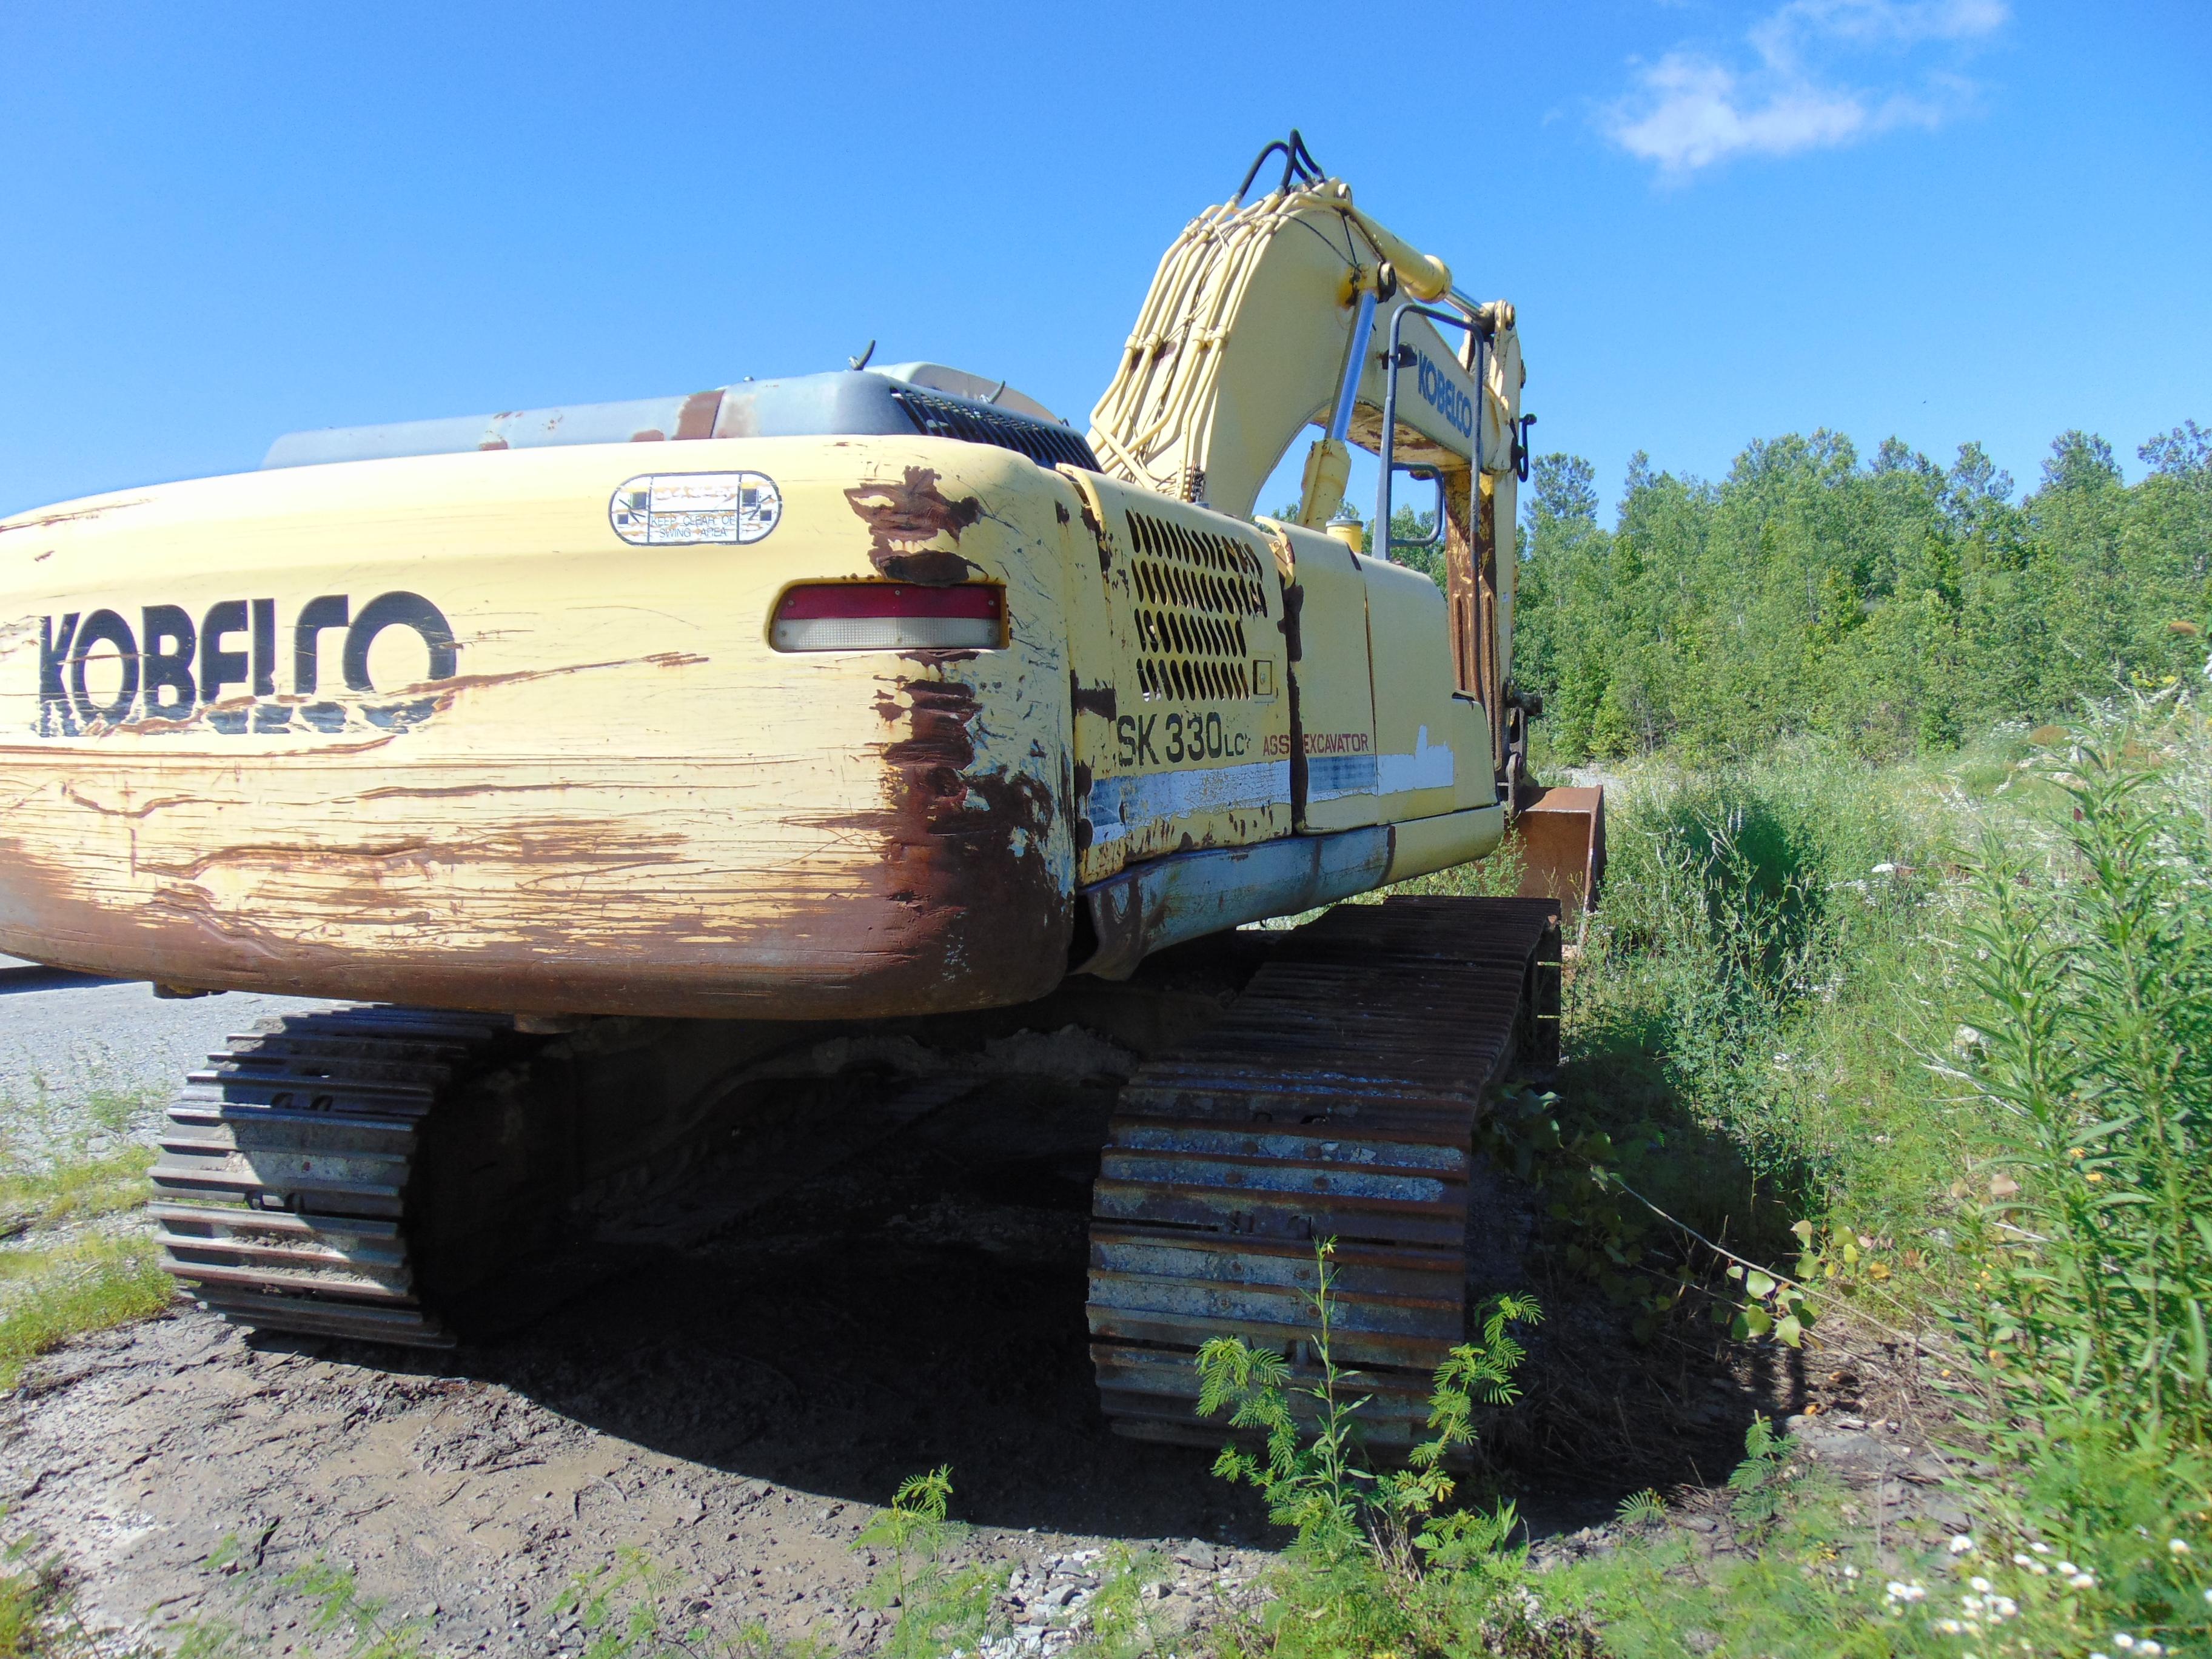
[332,1078,1798,1544]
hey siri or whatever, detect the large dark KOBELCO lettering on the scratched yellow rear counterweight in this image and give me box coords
[35,593,460,737]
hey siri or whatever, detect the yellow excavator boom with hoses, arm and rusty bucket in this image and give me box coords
[1090,133,1604,911]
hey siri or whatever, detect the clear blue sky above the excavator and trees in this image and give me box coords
[0,0,2212,521]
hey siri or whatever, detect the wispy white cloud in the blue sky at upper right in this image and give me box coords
[1600,0,2011,181]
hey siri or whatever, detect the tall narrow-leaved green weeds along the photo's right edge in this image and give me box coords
[1945,729,2212,1641]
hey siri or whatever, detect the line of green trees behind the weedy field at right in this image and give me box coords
[1513,420,2212,763]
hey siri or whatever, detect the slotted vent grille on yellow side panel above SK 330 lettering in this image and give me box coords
[1128,513,1267,703]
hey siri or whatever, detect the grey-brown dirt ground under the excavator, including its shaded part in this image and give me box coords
[0,995,1973,1652]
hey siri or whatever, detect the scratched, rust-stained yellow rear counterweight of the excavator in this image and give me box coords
[0,438,1093,1017]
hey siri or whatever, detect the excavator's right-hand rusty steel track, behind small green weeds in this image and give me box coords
[1088,898,1560,1442]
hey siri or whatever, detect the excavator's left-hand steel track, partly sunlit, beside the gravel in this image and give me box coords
[150,1007,513,1347]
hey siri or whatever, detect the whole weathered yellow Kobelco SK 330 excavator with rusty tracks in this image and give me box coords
[0,133,1604,1440]
